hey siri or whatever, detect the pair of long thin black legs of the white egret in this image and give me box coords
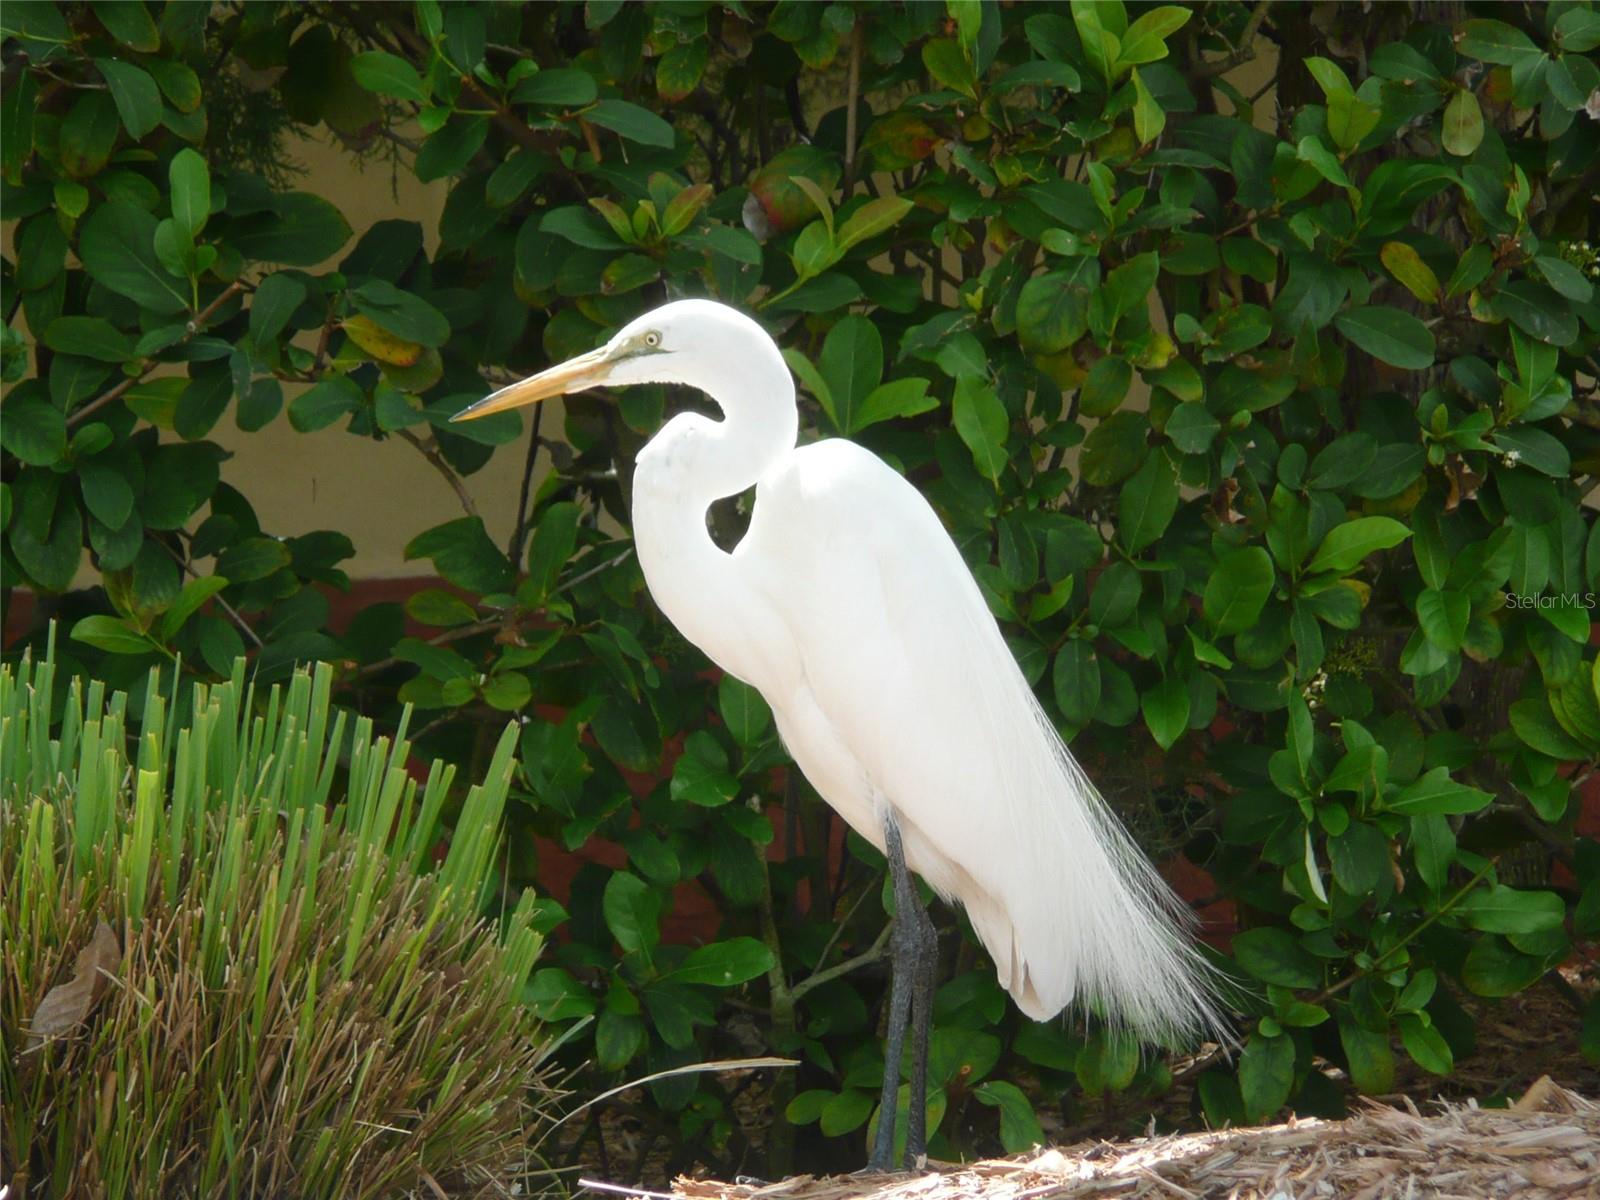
[867,814,938,1171]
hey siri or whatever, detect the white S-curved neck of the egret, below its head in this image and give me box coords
[634,336,800,683]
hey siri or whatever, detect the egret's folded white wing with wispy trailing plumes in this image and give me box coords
[736,442,1216,1040]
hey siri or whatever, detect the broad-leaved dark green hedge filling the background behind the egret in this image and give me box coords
[3,0,1600,1171]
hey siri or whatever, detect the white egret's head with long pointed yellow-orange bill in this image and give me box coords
[451,299,745,421]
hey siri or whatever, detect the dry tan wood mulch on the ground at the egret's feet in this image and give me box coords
[584,1077,1600,1200]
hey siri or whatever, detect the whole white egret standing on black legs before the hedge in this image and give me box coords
[456,299,1221,1170]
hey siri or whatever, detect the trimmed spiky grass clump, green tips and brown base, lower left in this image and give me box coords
[0,659,552,1198]
